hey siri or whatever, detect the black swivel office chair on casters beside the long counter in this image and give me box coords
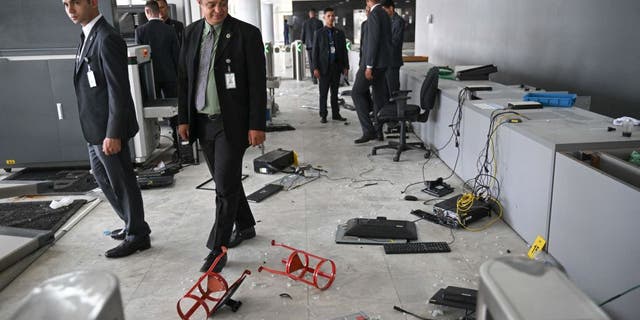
[371,66,438,162]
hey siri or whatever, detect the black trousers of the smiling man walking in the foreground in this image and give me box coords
[197,116,256,251]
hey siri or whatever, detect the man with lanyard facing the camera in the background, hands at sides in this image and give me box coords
[311,8,349,123]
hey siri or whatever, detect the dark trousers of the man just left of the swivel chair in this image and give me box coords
[351,66,388,137]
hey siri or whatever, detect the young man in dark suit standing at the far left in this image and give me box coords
[63,0,151,258]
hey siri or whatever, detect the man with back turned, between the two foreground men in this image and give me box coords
[136,0,180,98]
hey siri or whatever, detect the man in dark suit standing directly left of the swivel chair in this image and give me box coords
[351,0,391,144]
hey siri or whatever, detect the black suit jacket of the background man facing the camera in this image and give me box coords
[311,27,349,74]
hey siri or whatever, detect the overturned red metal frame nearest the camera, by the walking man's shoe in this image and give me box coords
[176,247,251,320]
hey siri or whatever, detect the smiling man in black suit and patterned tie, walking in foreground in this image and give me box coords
[178,0,267,272]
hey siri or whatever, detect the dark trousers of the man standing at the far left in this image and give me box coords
[89,141,151,240]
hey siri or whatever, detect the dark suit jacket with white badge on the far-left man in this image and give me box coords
[73,18,138,145]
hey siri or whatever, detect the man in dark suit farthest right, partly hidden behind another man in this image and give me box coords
[382,0,404,94]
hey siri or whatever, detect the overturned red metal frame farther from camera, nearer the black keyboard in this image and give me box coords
[258,240,336,290]
